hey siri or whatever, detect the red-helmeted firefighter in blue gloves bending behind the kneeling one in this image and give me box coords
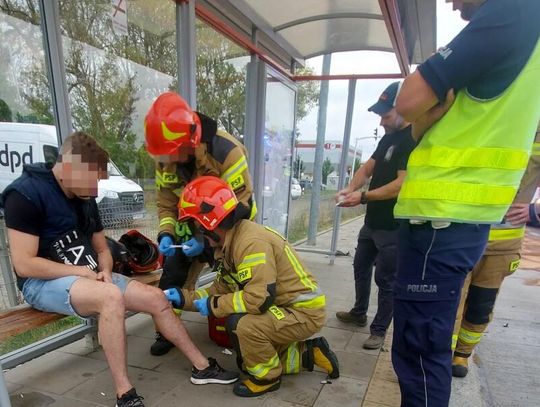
[144,92,257,355]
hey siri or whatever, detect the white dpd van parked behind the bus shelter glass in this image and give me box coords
[0,122,145,227]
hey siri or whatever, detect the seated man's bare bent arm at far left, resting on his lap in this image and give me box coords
[7,228,96,280]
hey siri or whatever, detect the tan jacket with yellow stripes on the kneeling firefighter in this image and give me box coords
[182,220,325,319]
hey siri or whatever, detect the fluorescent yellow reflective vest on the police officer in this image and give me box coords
[394,42,540,223]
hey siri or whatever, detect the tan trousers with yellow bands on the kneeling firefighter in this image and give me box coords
[227,305,326,382]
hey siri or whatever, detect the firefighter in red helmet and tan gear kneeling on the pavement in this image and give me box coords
[173,177,339,397]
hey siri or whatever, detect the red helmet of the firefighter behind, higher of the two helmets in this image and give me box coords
[144,92,201,155]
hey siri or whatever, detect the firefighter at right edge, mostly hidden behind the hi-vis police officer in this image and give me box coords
[452,125,540,377]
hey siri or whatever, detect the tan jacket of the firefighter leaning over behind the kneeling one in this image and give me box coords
[156,113,257,241]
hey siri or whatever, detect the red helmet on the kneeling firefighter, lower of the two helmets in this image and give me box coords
[178,176,238,230]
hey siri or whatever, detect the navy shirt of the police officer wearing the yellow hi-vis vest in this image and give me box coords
[418,0,540,102]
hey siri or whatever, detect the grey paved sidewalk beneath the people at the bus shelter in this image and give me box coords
[6,219,540,407]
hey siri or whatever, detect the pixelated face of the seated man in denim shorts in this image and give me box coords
[61,153,108,199]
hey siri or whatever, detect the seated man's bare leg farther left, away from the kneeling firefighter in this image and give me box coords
[70,278,133,397]
